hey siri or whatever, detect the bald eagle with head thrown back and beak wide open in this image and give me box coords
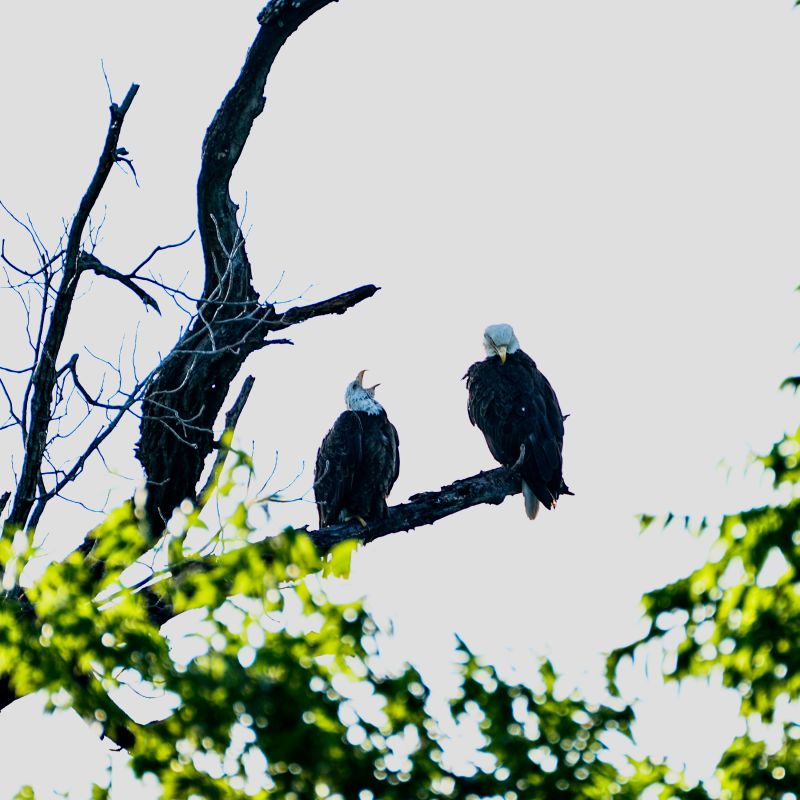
[314,369,400,528]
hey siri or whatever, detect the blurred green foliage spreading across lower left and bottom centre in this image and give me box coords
[0,472,654,800]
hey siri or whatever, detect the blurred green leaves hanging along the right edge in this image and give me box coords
[609,422,800,800]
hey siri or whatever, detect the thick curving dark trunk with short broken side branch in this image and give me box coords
[137,0,377,535]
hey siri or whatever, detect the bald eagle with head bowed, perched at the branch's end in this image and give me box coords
[464,324,572,519]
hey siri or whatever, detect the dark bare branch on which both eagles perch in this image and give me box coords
[307,466,522,551]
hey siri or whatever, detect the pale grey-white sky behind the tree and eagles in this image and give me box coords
[0,0,800,798]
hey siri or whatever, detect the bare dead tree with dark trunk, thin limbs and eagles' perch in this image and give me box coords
[0,0,518,545]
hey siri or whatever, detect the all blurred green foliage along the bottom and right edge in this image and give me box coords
[0,354,800,800]
